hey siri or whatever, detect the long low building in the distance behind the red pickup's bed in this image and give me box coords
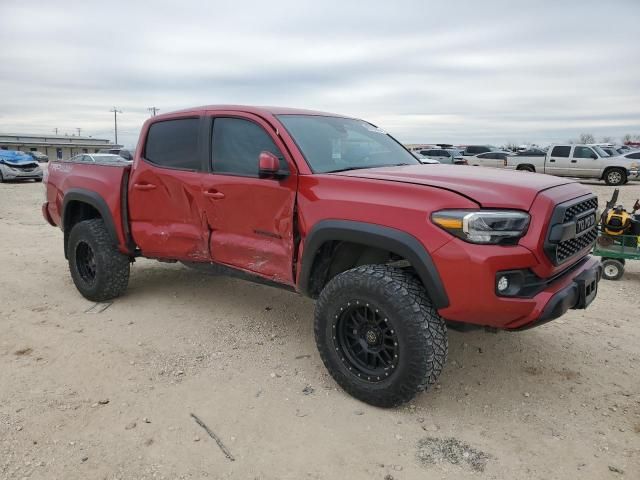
[0,133,122,160]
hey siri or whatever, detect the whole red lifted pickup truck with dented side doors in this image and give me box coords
[42,106,601,407]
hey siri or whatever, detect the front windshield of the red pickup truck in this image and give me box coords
[278,115,420,173]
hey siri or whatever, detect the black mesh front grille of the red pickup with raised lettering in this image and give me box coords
[545,195,598,265]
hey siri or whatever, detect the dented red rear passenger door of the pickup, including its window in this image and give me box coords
[129,115,210,261]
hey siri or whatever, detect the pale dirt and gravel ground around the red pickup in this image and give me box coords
[0,178,640,480]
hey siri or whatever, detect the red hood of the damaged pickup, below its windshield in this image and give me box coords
[331,165,575,210]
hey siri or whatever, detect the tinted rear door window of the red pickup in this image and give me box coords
[144,118,202,170]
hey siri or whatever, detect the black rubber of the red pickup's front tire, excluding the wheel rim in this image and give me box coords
[315,265,448,407]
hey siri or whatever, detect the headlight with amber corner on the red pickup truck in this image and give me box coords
[431,210,530,245]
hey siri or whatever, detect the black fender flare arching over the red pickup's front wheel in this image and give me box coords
[299,220,449,309]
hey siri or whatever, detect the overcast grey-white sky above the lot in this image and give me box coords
[0,0,640,146]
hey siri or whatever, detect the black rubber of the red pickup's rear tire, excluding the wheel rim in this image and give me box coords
[67,219,130,302]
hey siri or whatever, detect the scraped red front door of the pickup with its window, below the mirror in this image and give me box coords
[202,112,297,285]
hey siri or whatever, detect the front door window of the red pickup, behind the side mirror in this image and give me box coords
[211,117,287,177]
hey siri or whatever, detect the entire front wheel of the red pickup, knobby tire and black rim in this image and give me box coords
[315,265,448,407]
